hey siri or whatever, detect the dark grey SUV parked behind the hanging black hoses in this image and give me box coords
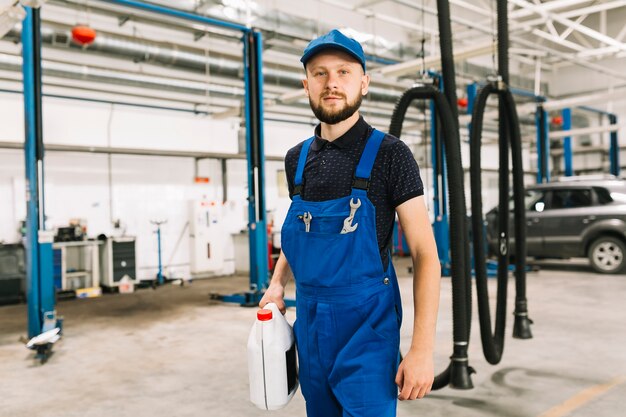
[486,177,626,274]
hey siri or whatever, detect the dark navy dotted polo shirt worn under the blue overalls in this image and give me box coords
[285,116,424,268]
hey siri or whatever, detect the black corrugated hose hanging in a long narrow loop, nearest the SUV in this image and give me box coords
[470,0,532,364]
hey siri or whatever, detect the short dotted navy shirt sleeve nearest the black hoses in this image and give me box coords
[387,139,424,208]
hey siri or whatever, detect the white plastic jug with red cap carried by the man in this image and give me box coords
[248,303,298,410]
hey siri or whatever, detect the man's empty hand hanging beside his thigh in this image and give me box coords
[396,350,435,401]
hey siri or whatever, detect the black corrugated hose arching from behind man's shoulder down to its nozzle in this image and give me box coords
[389,85,474,389]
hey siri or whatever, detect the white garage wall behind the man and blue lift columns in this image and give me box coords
[0,93,536,279]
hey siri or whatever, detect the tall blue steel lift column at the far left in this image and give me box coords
[22,7,42,338]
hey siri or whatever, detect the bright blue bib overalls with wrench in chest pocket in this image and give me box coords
[282,130,402,417]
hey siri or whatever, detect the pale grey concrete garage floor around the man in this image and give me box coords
[0,259,626,417]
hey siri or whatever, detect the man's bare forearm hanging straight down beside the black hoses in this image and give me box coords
[411,252,441,355]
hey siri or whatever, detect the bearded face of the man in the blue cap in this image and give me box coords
[302,50,370,125]
